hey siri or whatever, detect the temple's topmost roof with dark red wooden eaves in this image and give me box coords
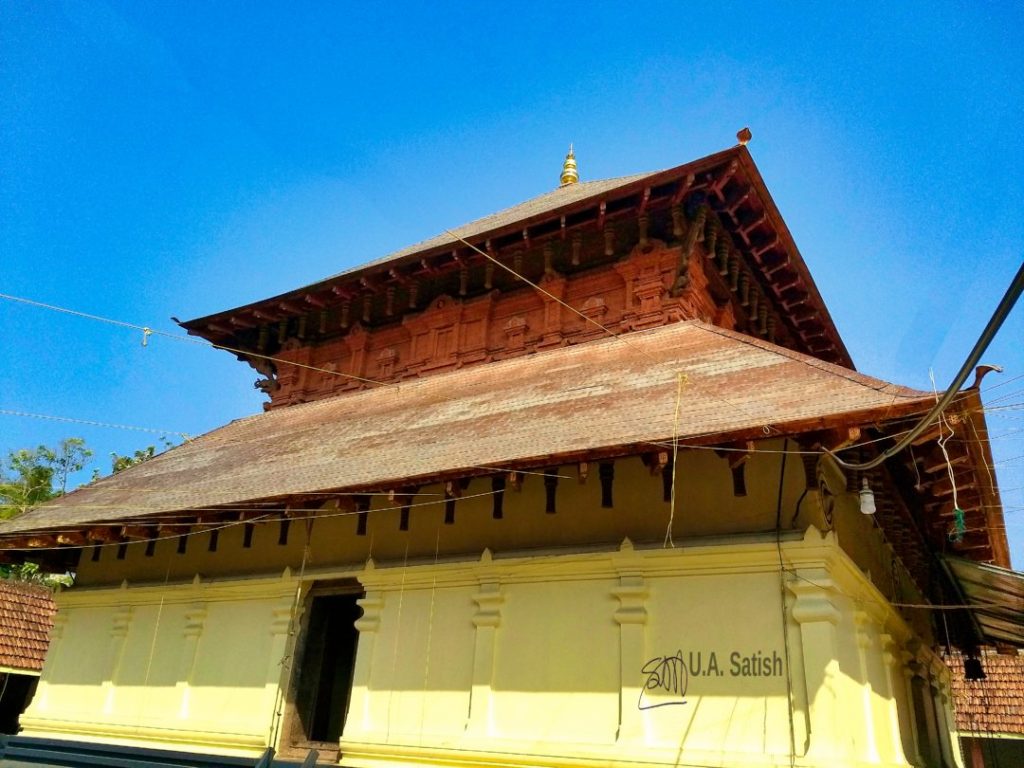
[181,145,853,368]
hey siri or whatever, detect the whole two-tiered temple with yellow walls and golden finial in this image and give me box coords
[0,140,1024,768]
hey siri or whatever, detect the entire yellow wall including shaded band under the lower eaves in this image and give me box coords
[28,440,956,766]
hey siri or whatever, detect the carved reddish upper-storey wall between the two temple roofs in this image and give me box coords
[261,239,739,407]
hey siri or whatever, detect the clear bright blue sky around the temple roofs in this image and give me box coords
[0,0,1024,566]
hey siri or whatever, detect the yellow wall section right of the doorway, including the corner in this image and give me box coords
[342,528,952,766]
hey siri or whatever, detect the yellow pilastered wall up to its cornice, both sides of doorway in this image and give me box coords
[23,528,955,766]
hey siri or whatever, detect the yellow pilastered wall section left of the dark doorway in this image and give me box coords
[20,572,297,754]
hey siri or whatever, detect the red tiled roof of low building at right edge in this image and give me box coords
[946,650,1024,736]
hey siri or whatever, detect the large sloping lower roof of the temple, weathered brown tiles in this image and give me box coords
[0,322,934,537]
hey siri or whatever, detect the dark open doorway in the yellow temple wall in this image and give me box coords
[295,592,362,744]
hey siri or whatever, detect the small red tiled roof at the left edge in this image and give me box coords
[0,579,56,672]
